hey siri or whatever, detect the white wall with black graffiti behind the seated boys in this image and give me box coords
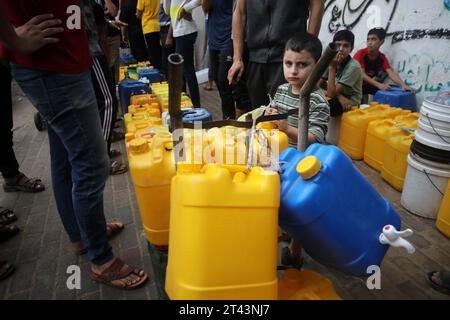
[319,0,450,106]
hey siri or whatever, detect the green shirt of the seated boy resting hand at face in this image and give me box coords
[322,56,363,106]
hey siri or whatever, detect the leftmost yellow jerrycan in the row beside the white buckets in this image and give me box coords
[338,104,410,160]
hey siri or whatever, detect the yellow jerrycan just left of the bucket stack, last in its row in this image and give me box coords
[381,131,413,191]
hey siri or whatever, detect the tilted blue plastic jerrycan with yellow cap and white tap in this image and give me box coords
[279,144,404,277]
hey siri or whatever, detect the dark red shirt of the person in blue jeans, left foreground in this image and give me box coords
[0,0,91,74]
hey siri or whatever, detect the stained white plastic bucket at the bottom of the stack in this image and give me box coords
[401,153,450,219]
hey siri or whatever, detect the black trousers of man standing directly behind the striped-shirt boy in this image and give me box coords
[247,61,286,109]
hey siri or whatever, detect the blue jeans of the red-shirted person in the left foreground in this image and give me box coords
[11,64,113,265]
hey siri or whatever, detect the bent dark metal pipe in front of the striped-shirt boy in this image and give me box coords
[297,42,339,152]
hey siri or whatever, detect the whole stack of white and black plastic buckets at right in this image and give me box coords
[401,91,450,220]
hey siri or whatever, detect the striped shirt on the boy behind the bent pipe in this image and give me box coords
[272,83,330,147]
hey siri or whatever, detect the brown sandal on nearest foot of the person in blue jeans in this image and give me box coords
[91,258,148,290]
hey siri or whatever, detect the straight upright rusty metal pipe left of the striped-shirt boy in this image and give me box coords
[167,53,184,163]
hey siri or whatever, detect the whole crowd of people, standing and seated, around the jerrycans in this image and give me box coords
[0,0,449,296]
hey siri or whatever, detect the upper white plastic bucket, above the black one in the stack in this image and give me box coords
[415,99,450,150]
